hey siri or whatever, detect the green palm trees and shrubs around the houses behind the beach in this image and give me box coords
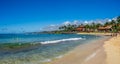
[58,16,120,33]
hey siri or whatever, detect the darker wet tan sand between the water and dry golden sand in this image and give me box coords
[45,34,110,64]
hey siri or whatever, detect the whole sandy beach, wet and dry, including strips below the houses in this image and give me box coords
[46,33,120,64]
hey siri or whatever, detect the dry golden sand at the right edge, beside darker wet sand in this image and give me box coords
[104,35,120,64]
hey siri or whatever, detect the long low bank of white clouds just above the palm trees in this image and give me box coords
[42,18,115,31]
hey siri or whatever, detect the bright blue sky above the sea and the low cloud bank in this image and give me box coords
[0,0,120,33]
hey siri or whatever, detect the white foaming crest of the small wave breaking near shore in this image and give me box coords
[40,37,83,44]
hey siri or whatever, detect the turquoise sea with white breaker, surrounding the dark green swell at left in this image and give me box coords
[0,34,101,64]
